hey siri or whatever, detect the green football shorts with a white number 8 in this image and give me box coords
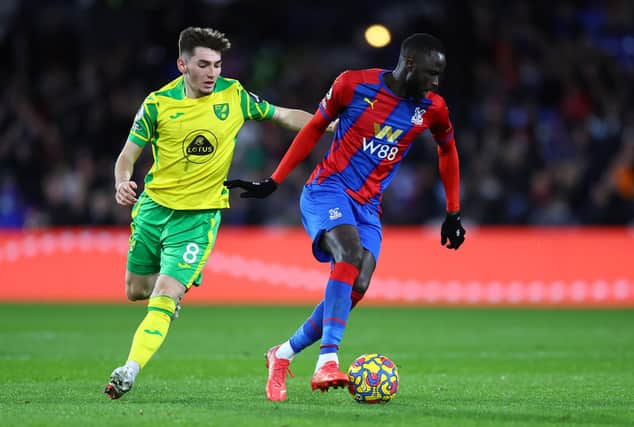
[127,192,220,288]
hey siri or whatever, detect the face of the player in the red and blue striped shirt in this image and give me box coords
[405,50,447,98]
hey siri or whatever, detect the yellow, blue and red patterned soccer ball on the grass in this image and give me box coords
[348,353,398,403]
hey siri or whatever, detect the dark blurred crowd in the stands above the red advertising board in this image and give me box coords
[0,0,634,227]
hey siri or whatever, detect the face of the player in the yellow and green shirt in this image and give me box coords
[177,47,222,98]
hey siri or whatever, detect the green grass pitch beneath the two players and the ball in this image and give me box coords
[0,304,634,427]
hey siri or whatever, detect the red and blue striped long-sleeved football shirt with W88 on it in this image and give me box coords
[272,69,459,210]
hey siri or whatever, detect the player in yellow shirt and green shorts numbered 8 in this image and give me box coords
[105,27,332,399]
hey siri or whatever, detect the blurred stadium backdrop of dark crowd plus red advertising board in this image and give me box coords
[0,0,634,306]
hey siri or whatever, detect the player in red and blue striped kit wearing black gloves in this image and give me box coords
[226,33,465,401]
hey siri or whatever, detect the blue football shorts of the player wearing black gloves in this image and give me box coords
[299,184,383,262]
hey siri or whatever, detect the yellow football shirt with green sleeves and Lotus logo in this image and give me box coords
[128,76,275,210]
